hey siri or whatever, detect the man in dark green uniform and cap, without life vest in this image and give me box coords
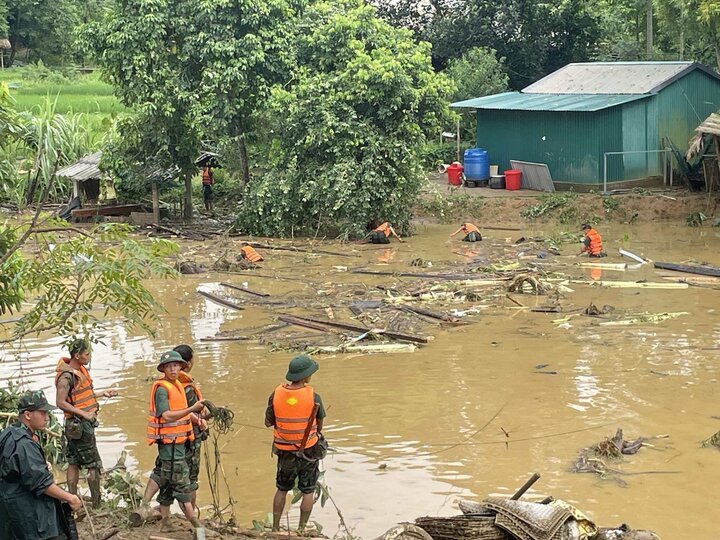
[0,391,82,540]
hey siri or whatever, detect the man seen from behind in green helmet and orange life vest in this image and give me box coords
[265,355,325,531]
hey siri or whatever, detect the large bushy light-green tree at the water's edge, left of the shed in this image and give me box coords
[237,0,452,236]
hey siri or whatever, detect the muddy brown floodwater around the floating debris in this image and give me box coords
[0,224,720,540]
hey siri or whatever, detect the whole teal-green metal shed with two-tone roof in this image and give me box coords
[451,62,720,189]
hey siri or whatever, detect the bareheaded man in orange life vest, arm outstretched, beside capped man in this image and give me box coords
[55,339,117,508]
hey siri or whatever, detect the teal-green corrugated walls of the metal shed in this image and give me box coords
[477,70,720,185]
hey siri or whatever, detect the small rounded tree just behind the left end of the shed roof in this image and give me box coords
[445,47,508,101]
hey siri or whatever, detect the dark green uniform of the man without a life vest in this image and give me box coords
[0,423,65,540]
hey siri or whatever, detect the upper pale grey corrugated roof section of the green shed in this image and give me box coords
[523,62,718,95]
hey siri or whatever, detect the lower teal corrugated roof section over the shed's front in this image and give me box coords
[450,92,650,112]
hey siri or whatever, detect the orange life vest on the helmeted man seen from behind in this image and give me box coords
[273,384,318,452]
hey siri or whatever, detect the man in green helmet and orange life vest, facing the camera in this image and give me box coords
[143,351,204,530]
